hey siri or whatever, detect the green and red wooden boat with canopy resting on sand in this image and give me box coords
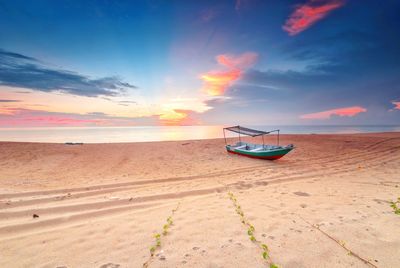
[223,126,294,160]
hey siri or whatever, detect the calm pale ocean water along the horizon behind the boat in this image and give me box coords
[0,125,400,143]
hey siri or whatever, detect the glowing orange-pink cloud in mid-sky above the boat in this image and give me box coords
[201,52,258,96]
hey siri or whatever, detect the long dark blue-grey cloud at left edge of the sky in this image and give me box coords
[0,49,136,97]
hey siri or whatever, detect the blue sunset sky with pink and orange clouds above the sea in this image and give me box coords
[0,0,400,127]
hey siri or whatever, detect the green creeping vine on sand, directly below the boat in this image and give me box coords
[228,192,279,268]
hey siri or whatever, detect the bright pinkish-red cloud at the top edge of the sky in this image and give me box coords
[282,0,344,35]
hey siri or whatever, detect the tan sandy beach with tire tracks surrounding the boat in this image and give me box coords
[0,133,400,268]
